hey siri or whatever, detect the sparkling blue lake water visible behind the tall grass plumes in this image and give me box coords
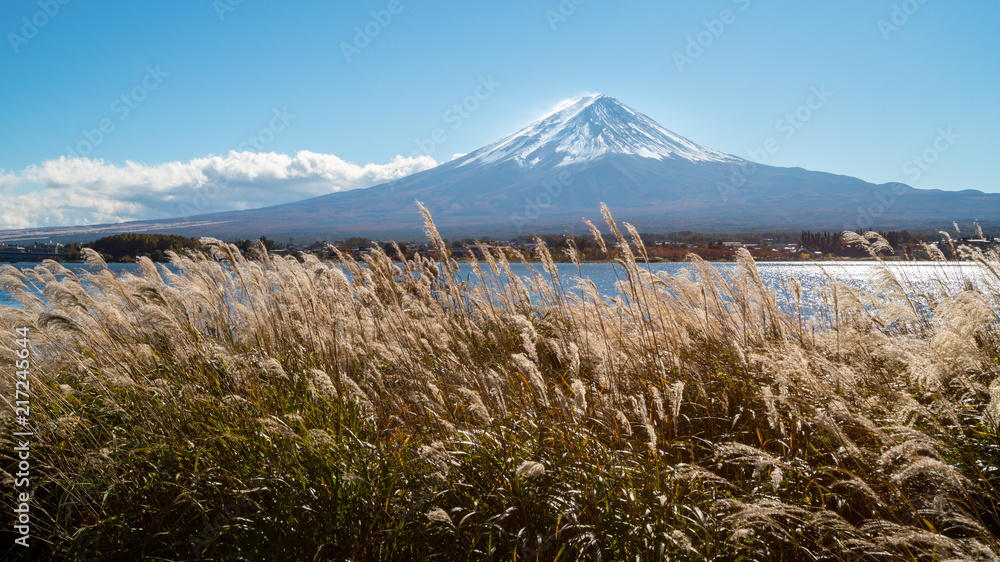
[0,261,981,306]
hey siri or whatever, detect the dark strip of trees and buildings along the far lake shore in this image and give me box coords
[0,226,995,263]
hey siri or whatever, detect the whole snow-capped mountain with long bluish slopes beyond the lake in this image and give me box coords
[0,95,1000,240]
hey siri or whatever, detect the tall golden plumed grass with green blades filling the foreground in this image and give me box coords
[0,203,1000,561]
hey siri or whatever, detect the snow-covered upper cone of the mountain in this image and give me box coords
[458,94,739,168]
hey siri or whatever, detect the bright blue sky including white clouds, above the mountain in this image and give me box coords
[0,0,1000,228]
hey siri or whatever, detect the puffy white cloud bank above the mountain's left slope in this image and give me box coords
[0,150,437,229]
